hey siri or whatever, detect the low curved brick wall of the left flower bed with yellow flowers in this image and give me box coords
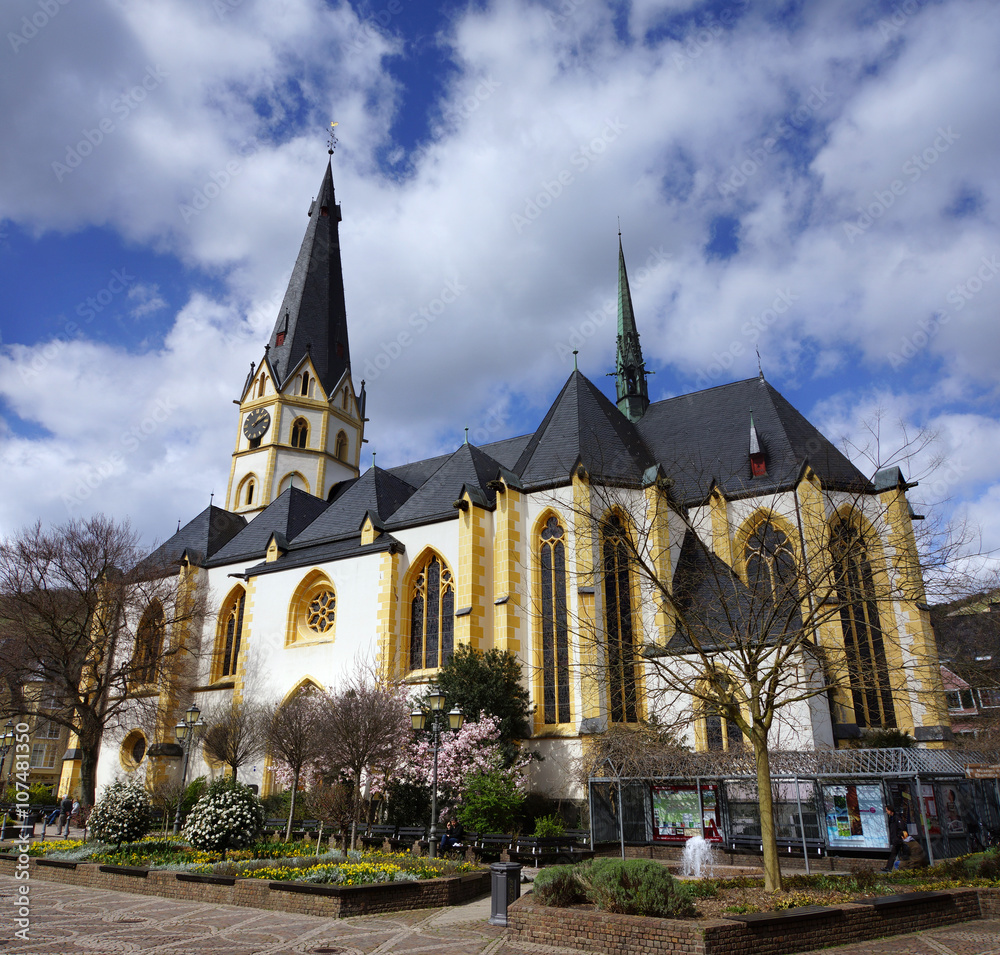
[0,856,490,918]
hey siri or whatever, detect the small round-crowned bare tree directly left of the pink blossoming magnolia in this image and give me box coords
[324,669,410,848]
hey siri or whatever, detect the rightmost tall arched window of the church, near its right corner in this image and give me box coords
[831,521,896,727]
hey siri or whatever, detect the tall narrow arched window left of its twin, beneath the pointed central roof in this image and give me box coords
[538,517,572,723]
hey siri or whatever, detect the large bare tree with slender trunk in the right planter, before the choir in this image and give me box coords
[556,430,958,891]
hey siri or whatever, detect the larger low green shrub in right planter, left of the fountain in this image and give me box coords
[580,859,695,918]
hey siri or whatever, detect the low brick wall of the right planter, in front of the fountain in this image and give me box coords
[507,889,1000,955]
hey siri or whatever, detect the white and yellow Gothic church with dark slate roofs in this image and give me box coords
[74,165,949,798]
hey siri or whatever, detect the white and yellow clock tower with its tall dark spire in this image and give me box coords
[226,153,365,516]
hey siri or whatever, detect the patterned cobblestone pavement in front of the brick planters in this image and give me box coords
[0,876,1000,955]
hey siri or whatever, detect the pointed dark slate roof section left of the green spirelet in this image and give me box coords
[513,370,655,490]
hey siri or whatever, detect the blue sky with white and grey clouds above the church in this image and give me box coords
[0,0,1000,576]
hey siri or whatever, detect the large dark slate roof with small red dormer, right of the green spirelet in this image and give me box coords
[637,377,868,504]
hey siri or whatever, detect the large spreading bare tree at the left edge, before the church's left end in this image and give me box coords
[0,515,204,804]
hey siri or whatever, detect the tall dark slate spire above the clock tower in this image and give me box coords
[268,163,351,394]
